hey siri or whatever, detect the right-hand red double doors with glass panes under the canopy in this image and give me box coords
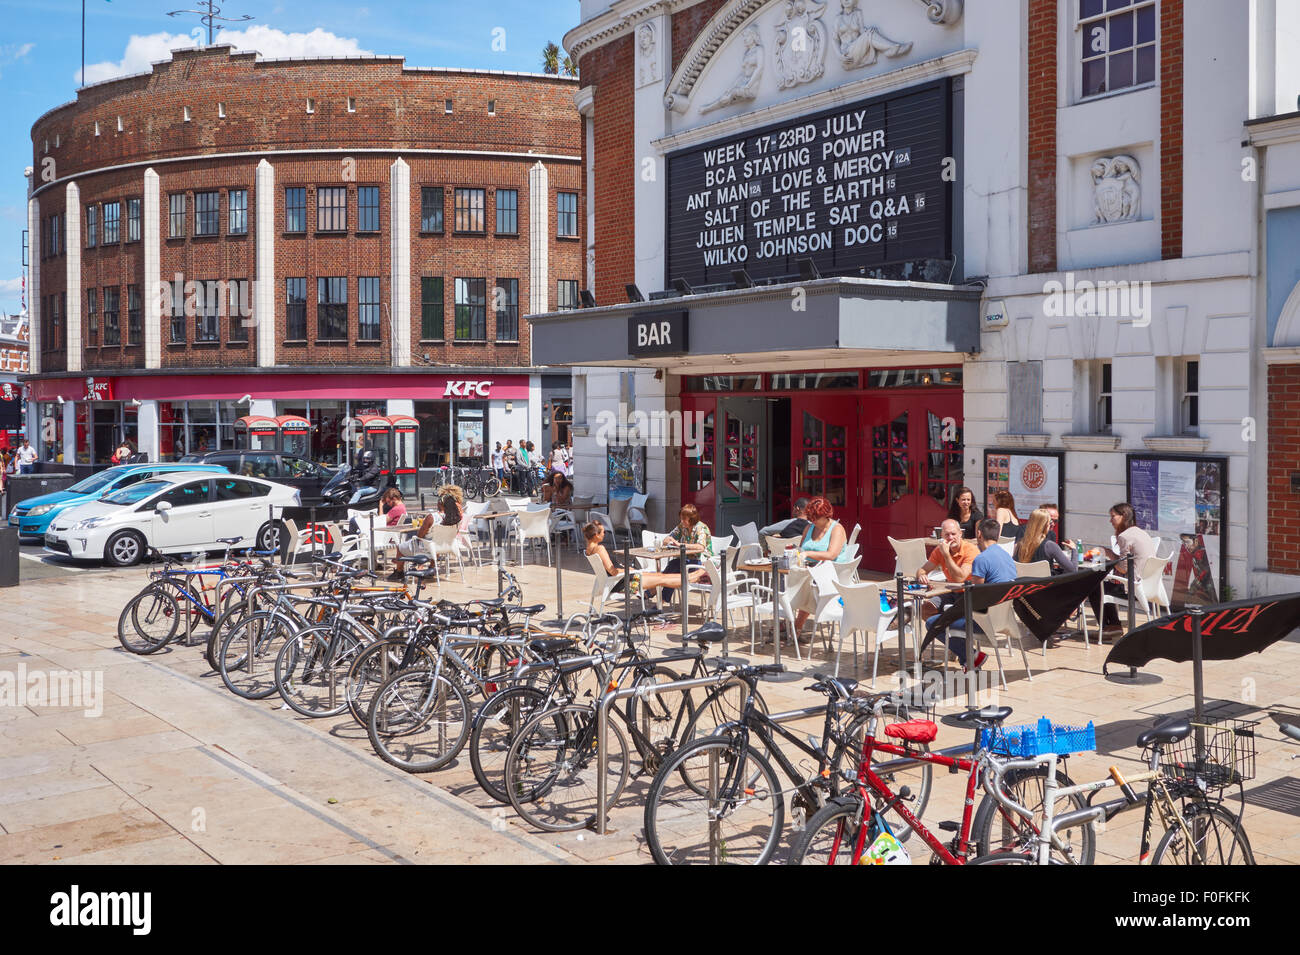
[858,391,963,573]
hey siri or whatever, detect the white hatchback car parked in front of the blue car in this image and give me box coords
[46,470,300,567]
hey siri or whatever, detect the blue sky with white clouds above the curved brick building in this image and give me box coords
[0,0,579,313]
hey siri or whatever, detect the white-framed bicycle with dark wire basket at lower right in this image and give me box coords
[972,720,1253,865]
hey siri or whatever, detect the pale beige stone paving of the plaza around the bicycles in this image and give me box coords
[0,552,1300,864]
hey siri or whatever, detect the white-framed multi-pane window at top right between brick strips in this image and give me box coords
[1079,0,1156,96]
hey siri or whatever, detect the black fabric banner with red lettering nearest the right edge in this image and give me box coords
[1101,594,1300,673]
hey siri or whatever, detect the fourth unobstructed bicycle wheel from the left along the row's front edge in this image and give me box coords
[365,670,469,773]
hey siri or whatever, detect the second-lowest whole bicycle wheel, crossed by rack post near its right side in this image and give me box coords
[506,704,628,833]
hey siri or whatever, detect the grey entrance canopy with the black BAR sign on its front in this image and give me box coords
[528,278,982,374]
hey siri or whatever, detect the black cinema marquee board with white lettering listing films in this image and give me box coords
[664,81,957,286]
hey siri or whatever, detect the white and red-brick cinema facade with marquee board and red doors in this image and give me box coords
[529,0,1300,603]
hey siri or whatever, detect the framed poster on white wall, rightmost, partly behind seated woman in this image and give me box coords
[1127,455,1227,611]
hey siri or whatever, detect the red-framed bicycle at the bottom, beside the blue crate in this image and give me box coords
[790,696,1095,865]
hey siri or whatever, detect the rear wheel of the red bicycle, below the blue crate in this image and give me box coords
[971,767,1097,865]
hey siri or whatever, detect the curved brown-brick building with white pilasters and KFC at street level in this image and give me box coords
[27,47,585,466]
